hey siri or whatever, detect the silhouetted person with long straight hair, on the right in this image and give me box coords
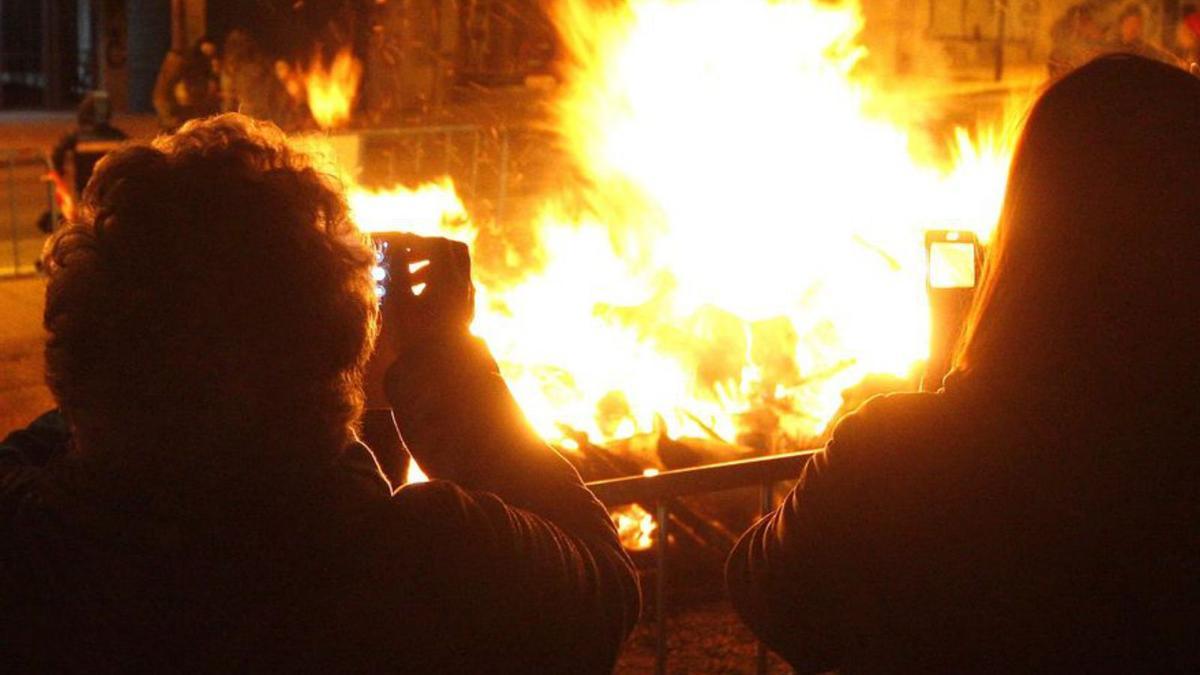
[726,56,1200,673]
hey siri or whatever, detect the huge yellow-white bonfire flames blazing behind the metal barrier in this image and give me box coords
[310,0,1027,548]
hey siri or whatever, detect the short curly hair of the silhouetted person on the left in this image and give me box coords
[43,114,376,462]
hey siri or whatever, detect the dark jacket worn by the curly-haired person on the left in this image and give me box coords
[0,341,638,673]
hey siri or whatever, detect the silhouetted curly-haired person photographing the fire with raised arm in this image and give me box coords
[0,114,638,673]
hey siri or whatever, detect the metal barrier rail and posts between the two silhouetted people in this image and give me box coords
[588,449,817,675]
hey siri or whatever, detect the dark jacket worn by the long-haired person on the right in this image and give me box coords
[726,386,1200,673]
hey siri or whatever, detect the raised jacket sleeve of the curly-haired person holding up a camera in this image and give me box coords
[386,336,640,670]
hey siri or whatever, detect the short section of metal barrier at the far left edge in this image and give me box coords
[0,148,58,277]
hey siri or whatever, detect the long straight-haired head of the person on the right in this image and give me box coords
[955,55,1200,403]
